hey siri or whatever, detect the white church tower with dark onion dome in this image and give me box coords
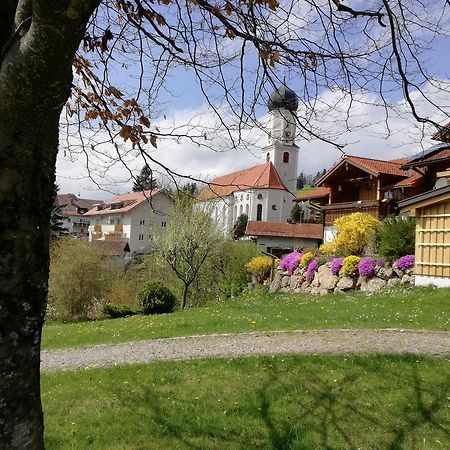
[262,85,298,195]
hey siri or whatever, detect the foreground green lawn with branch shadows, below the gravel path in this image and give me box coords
[42,355,450,450]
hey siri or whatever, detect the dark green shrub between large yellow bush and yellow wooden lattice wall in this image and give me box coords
[374,216,416,262]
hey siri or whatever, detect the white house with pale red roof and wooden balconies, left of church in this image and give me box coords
[85,189,172,254]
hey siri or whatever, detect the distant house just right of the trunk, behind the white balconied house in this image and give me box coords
[55,193,101,238]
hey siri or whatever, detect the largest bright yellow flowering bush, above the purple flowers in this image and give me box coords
[320,213,378,256]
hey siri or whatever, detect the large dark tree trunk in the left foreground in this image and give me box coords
[0,0,99,450]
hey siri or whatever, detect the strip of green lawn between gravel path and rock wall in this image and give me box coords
[43,287,450,348]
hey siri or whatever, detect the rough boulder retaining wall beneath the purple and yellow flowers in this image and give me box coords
[270,262,414,295]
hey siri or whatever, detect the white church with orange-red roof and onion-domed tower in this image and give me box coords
[198,86,299,234]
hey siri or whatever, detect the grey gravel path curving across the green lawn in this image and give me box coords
[41,329,450,371]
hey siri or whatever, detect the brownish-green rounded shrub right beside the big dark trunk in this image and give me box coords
[48,237,108,320]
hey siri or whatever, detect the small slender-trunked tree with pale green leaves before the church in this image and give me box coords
[150,199,223,308]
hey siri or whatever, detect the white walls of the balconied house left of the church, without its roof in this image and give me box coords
[89,192,172,253]
